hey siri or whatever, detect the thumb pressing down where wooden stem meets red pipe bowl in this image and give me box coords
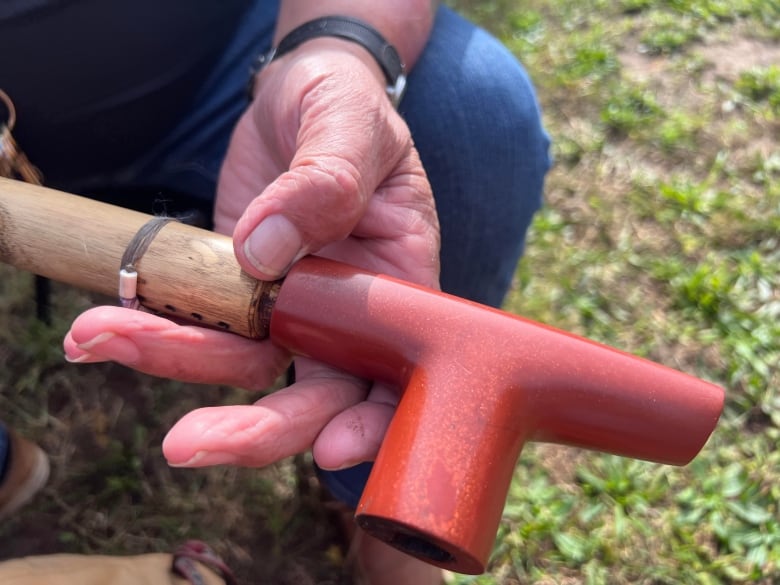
[233,66,412,279]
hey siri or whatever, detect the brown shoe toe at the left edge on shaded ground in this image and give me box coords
[0,431,49,520]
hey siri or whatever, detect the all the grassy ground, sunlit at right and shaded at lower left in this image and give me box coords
[0,0,780,585]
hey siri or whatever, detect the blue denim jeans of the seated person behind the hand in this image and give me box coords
[68,0,550,506]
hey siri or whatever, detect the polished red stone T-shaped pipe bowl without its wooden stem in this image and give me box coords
[271,259,724,574]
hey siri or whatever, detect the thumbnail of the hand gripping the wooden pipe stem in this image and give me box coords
[244,215,302,278]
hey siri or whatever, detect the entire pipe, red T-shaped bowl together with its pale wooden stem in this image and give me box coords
[0,179,724,574]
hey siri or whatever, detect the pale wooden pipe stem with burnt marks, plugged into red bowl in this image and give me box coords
[0,179,278,339]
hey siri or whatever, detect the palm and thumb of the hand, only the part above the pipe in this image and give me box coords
[215,39,439,287]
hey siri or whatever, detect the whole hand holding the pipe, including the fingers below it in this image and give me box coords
[66,39,439,468]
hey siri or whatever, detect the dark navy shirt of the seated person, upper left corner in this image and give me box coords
[0,0,251,186]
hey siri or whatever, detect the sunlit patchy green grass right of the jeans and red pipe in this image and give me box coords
[444,0,780,584]
